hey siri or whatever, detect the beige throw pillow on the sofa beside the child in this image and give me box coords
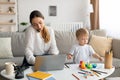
[89,35,112,56]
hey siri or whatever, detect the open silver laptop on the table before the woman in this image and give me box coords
[33,54,66,71]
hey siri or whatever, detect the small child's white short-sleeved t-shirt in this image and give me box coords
[70,44,95,64]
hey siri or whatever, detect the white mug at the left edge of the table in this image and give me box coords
[5,62,14,75]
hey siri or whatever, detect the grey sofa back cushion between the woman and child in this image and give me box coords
[55,31,77,54]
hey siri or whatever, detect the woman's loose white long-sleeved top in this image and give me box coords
[25,26,59,64]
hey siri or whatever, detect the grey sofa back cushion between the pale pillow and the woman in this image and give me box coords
[11,32,25,57]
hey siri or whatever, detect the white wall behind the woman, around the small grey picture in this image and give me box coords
[18,0,89,31]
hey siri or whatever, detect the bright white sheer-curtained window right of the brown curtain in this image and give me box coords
[99,0,120,38]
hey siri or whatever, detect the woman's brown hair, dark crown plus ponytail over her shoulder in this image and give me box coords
[30,10,50,43]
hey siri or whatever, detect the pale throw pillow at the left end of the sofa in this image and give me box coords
[0,38,13,58]
